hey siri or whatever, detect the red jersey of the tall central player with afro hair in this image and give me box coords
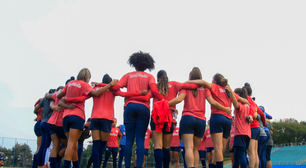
[117,71,155,109]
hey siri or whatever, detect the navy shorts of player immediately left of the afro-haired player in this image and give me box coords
[89,118,113,132]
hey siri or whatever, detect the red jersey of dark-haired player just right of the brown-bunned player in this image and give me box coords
[234,102,251,138]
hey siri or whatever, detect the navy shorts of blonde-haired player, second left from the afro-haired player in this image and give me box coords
[63,115,85,132]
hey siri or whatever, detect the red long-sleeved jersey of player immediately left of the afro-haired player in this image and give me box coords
[91,86,140,121]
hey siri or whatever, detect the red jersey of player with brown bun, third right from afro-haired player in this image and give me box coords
[210,83,239,119]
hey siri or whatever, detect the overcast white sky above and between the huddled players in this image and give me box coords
[0,0,306,148]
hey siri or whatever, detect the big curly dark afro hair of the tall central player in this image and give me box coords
[127,51,155,71]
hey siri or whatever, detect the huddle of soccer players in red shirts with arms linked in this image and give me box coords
[33,51,268,168]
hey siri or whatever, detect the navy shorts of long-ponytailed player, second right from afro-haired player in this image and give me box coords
[179,115,206,138]
